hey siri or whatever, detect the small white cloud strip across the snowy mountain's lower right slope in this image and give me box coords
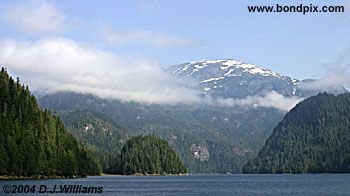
[215,91,302,111]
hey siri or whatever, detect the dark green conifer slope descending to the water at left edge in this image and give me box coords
[0,68,100,176]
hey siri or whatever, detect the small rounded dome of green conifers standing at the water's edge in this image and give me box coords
[119,135,186,174]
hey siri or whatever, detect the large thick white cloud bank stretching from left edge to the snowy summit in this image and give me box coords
[0,38,200,103]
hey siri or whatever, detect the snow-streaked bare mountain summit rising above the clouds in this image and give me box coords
[166,59,347,99]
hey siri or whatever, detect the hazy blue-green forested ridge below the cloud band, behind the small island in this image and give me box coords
[40,92,283,173]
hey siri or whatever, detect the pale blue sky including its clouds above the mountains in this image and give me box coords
[0,0,350,109]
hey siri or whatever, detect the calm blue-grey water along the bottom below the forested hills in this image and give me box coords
[0,174,350,196]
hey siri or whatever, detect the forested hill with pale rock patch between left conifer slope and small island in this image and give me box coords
[60,110,128,173]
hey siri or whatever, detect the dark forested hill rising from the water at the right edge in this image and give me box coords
[243,93,350,173]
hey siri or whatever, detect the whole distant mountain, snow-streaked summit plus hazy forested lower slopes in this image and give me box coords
[40,59,346,173]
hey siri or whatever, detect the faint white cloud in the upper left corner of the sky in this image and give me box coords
[2,0,65,33]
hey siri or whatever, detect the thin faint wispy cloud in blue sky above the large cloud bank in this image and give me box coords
[99,28,202,48]
